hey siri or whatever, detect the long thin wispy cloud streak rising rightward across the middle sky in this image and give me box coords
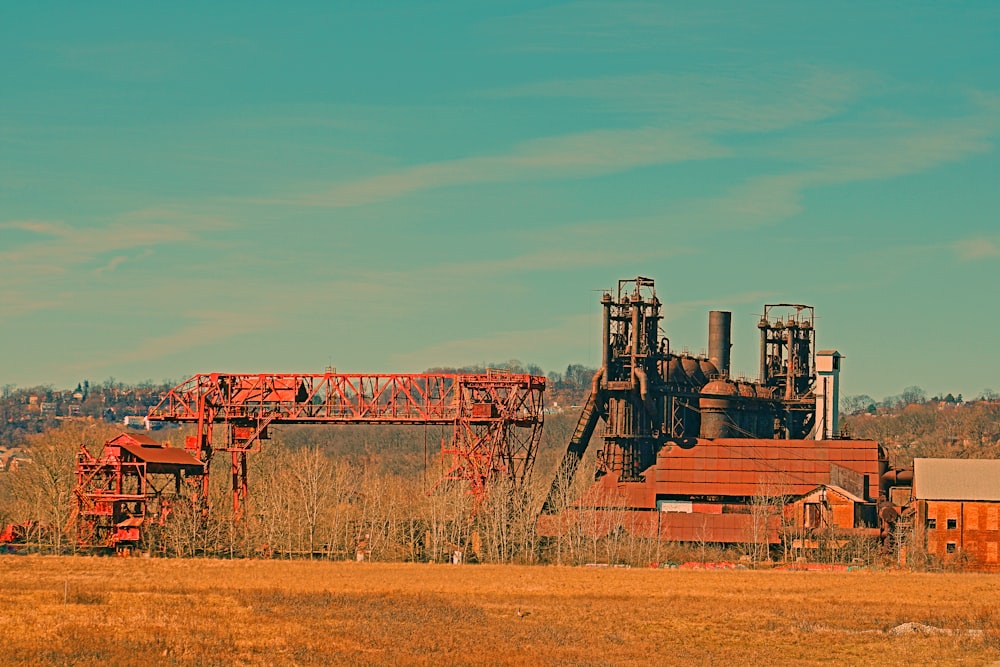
[269,127,729,207]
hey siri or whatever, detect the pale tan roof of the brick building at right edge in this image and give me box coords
[913,459,1000,501]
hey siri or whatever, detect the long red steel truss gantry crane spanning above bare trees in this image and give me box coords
[149,370,545,517]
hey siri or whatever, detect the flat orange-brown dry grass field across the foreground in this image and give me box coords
[0,556,1000,665]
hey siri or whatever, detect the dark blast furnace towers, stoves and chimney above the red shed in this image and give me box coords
[542,276,816,513]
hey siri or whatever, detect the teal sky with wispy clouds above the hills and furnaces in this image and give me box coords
[0,0,1000,398]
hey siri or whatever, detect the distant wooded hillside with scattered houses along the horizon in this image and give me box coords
[0,374,1000,476]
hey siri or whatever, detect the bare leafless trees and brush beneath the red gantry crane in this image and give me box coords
[0,415,696,564]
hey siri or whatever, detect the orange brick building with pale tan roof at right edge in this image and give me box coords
[911,459,1000,571]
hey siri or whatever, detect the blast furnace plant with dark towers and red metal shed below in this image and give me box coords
[539,276,904,543]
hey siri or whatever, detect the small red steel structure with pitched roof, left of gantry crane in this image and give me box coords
[73,433,206,550]
